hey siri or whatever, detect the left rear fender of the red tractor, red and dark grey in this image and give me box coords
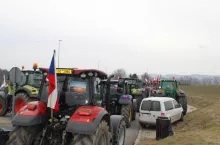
[11,101,48,126]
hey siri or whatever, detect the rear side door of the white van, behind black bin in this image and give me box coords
[164,101,175,123]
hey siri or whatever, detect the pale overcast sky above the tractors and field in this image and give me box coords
[0,0,220,75]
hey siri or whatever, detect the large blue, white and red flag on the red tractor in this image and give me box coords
[47,51,59,112]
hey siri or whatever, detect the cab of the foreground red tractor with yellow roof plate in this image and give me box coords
[40,68,107,111]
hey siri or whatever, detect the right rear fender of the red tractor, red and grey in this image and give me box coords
[66,106,110,135]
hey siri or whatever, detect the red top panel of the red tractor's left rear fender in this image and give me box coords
[18,101,47,116]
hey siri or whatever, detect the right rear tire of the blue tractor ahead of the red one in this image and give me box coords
[121,105,132,128]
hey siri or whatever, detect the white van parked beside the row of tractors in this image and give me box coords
[139,97,184,127]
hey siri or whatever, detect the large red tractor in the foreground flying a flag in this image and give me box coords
[6,68,126,145]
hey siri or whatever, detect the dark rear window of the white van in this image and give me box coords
[141,100,161,111]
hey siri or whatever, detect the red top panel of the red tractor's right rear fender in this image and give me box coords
[70,106,105,123]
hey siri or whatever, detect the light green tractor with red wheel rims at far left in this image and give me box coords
[0,64,47,116]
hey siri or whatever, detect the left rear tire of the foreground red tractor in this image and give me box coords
[6,125,42,145]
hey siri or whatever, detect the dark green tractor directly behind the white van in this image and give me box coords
[156,80,187,115]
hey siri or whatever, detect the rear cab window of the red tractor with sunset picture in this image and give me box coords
[41,76,90,106]
